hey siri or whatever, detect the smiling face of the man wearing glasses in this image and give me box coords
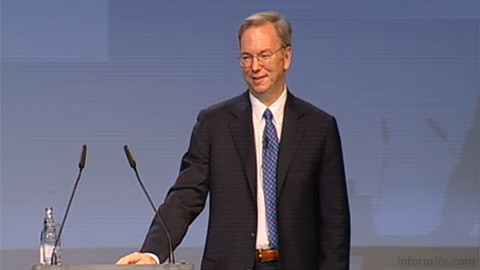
[240,23,292,96]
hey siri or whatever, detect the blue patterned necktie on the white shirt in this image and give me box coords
[263,109,279,248]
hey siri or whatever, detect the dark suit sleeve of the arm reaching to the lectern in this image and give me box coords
[140,109,210,262]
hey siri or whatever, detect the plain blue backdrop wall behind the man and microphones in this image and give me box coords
[1,0,480,255]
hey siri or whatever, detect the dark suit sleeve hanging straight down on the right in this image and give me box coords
[318,117,350,270]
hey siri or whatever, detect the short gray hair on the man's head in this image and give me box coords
[238,11,292,47]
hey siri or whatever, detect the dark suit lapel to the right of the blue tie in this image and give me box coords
[277,92,305,198]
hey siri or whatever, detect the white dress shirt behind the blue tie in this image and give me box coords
[250,87,287,249]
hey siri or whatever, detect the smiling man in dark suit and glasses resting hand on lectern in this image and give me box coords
[118,12,350,270]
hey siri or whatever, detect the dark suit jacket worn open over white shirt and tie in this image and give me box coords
[141,92,350,270]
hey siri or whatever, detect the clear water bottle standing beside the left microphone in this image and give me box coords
[40,207,60,265]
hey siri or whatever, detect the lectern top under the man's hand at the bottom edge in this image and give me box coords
[31,263,193,270]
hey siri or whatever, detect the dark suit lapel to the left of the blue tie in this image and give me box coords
[230,91,257,199]
